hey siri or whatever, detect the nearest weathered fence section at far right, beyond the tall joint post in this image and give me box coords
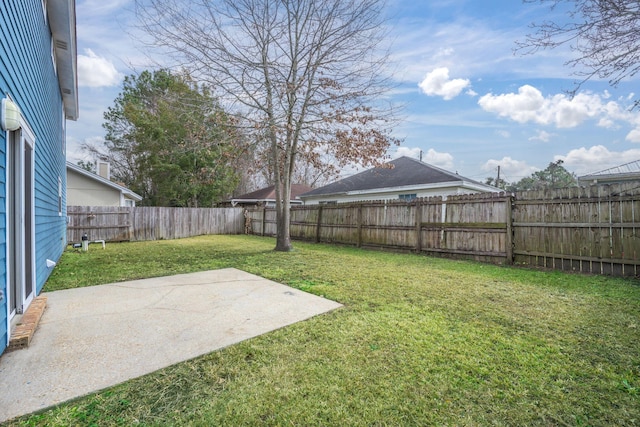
[512,183,640,276]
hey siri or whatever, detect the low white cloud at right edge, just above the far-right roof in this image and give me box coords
[554,145,640,175]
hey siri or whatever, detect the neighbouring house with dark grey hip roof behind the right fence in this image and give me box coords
[300,157,502,205]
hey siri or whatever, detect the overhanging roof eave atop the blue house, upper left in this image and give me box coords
[47,0,79,120]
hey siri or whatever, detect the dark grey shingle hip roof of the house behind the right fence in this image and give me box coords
[302,157,483,197]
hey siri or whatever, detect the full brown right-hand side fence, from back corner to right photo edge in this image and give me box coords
[247,183,640,276]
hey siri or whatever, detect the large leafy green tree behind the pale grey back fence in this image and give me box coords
[94,70,243,207]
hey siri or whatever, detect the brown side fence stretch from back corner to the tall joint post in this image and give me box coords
[247,193,512,262]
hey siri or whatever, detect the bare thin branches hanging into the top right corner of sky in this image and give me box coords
[517,0,640,103]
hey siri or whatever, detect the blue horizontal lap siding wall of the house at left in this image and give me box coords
[0,0,71,353]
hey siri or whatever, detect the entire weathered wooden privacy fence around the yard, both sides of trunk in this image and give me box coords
[67,182,640,276]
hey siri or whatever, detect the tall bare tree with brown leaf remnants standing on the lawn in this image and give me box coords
[137,0,398,251]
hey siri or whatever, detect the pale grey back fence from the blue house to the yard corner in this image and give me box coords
[67,206,244,243]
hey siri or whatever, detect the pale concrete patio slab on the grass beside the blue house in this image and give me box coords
[0,269,341,422]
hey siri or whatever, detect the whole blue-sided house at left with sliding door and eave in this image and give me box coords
[0,0,78,353]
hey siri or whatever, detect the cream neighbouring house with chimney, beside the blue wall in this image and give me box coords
[67,162,142,206]
